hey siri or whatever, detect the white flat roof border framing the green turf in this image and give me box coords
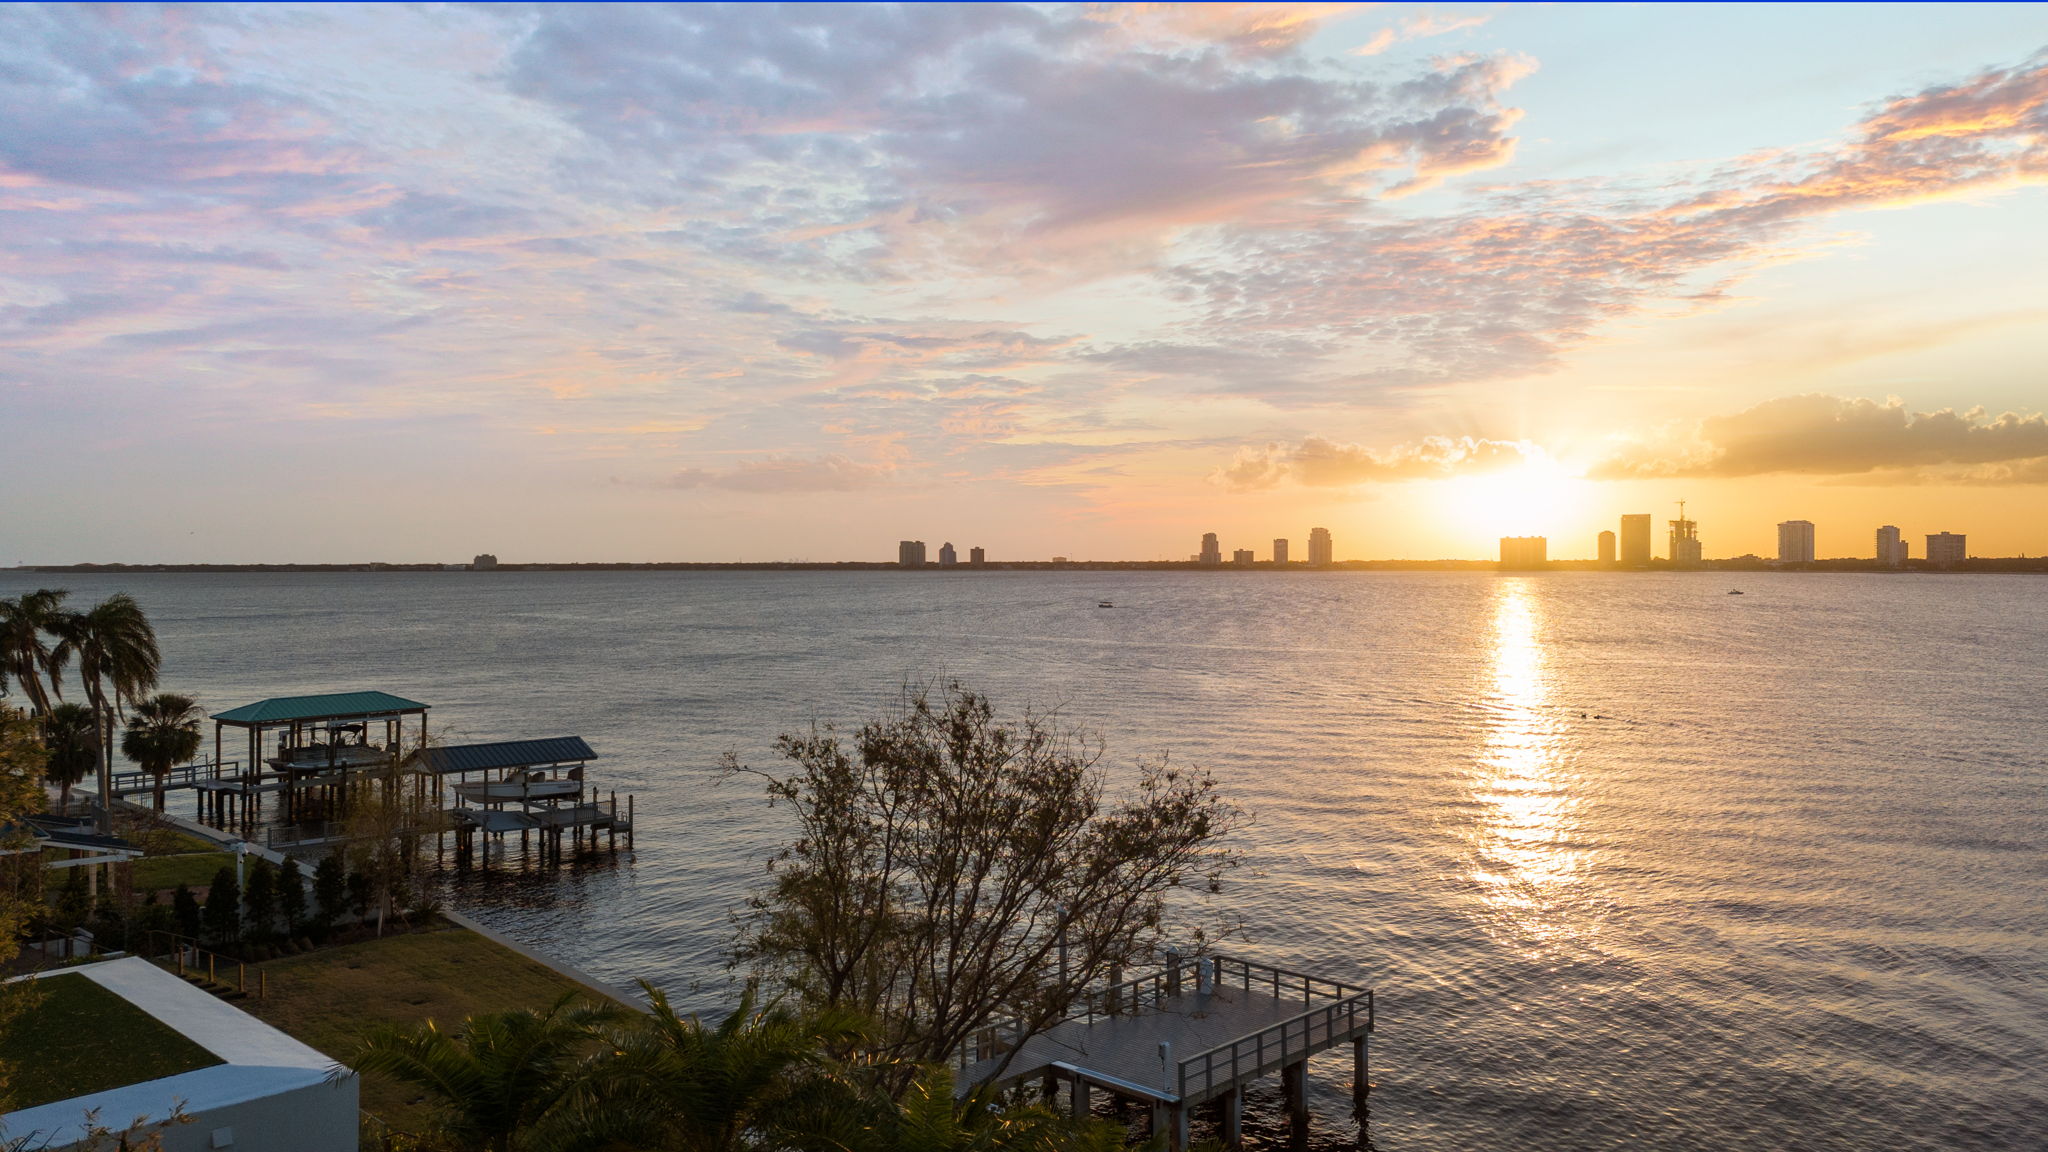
[4,957,352,1148]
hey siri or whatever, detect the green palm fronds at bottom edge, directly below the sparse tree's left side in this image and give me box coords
[549,980,872,1152]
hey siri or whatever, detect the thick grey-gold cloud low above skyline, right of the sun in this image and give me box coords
[1593,394,2048,484]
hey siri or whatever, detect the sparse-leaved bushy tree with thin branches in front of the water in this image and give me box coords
[727,685,1241,1086]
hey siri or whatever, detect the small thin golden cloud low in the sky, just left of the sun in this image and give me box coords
[1210,437,1542,483]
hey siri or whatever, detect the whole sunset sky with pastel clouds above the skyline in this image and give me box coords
[0,4,2048,566]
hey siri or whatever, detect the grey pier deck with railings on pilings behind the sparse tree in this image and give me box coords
[956,955,1372,1152]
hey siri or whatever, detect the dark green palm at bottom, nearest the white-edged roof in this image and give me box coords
[346,992,616,1152]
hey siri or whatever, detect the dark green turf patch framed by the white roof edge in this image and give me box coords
[0,972,223,1109]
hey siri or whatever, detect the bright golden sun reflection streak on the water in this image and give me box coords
[1473,580,1595,941]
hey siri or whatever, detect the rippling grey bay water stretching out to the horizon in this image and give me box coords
[0,570,2048,1152]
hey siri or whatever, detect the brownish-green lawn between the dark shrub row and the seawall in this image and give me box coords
[240,924,622,1132]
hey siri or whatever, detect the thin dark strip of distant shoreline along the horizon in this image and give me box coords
[16,556,2048,576]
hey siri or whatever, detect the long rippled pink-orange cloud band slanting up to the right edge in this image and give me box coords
[1163,53,2048,389]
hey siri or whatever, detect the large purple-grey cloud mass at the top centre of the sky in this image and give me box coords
[510,4,1528,266]
